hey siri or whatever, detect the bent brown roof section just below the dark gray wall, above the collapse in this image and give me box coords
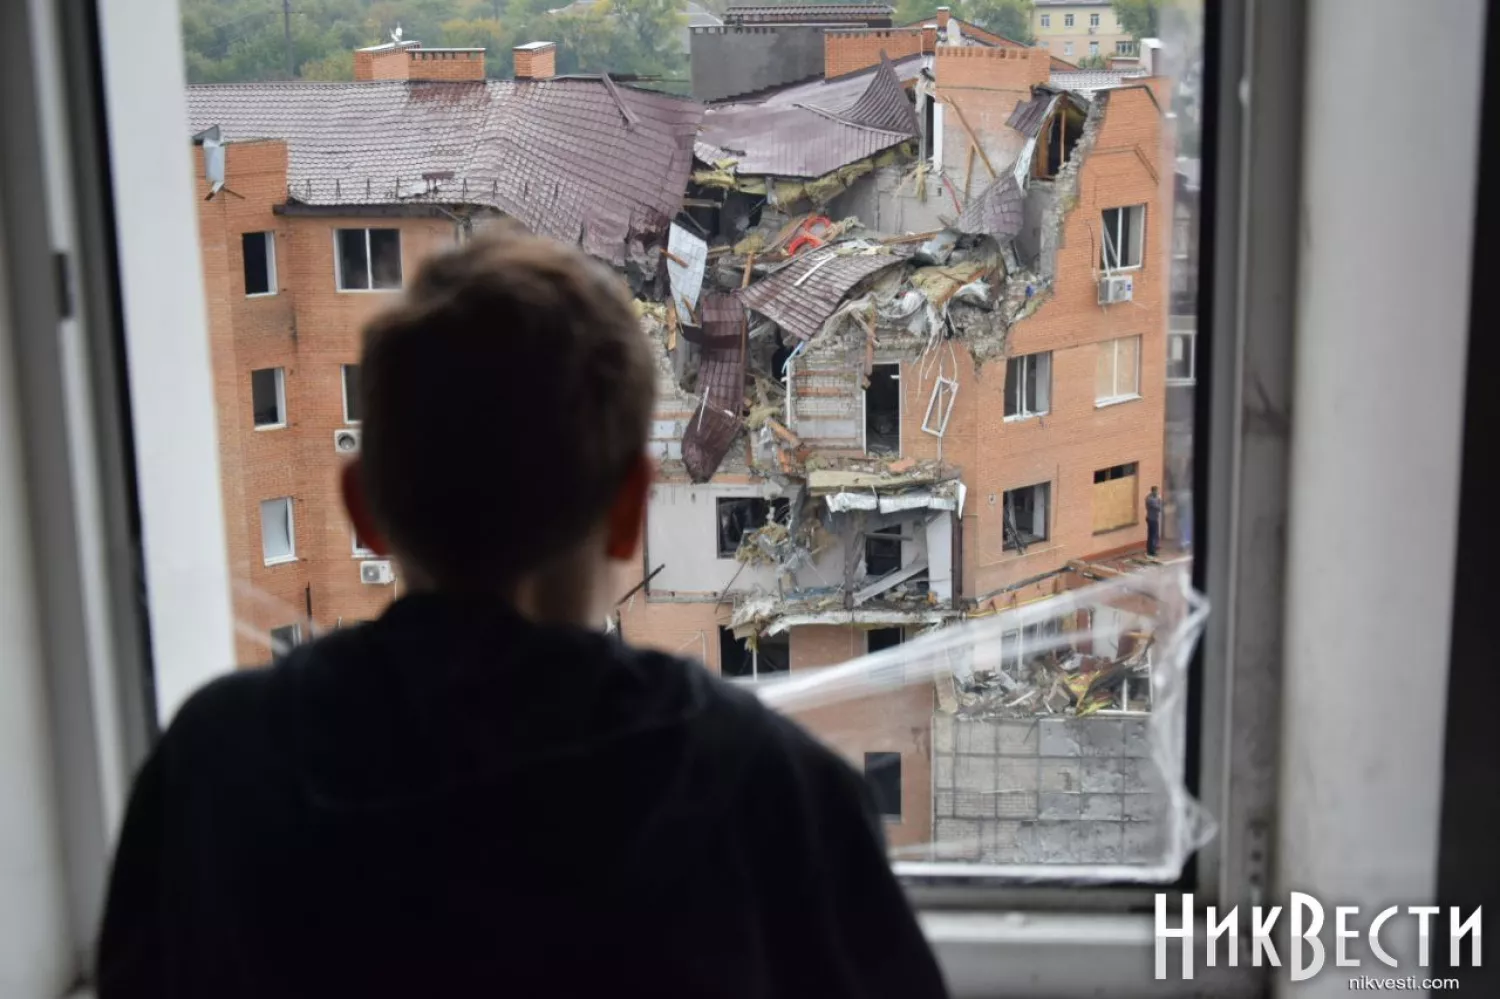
[695,59,920,177]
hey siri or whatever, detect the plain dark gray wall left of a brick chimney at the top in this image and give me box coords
[690,24,824,101]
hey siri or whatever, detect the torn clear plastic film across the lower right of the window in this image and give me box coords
[755,563,1215,882]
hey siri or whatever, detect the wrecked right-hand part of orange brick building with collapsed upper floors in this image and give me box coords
[620,17,1172,860]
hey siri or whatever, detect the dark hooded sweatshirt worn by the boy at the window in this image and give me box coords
[98,596,944,999]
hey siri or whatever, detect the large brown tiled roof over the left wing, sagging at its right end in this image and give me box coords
[188,78,702,263]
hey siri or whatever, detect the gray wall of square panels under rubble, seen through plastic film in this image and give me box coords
[933,713,1169,864]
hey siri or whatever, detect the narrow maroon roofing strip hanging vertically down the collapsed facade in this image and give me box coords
[683,293,746,482]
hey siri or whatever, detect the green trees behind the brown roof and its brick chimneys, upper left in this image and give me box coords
[183,0,687,83]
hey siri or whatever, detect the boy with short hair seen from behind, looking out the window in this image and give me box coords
[96,233,945,999]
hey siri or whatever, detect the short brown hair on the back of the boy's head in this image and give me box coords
[360,228,656,590]
